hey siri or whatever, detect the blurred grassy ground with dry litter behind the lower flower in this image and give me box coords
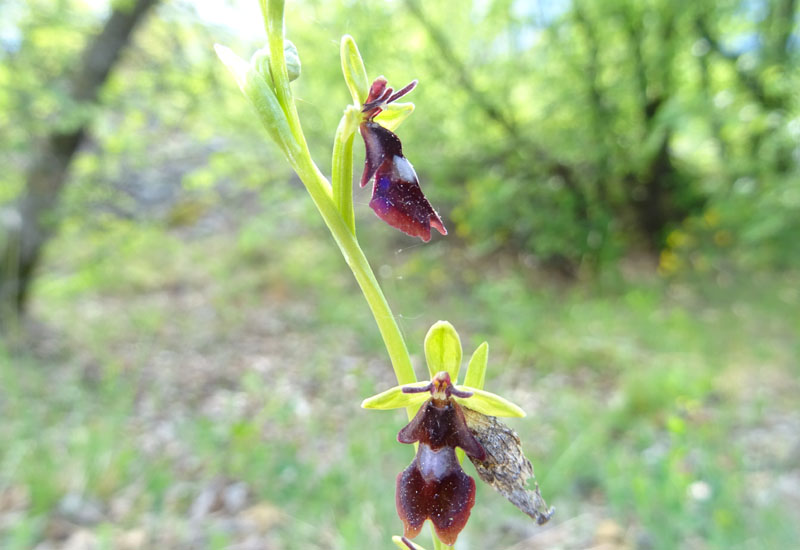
[0,208,800,550]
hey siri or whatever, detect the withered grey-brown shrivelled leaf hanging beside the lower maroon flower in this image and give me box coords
[462,406,555,525]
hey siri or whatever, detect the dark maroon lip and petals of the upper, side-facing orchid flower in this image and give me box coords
[359,77,447,242]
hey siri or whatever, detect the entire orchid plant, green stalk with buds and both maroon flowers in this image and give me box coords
[215,0,552,550]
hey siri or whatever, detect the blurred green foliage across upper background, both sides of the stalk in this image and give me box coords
[6,0,800,272]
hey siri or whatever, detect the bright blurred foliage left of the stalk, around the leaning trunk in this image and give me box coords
[0,1,289,246]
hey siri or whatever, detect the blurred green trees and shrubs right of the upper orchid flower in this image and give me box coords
[282,0,800,269]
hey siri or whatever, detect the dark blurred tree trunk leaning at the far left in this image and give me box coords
[0,0,157,329]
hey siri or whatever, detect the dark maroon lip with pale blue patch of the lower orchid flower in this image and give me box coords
[396,372,486,546]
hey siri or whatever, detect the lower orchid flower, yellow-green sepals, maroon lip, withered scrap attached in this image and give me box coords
[361,321,552,545]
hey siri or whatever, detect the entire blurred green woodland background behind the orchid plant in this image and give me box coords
[0,0,800,550]
